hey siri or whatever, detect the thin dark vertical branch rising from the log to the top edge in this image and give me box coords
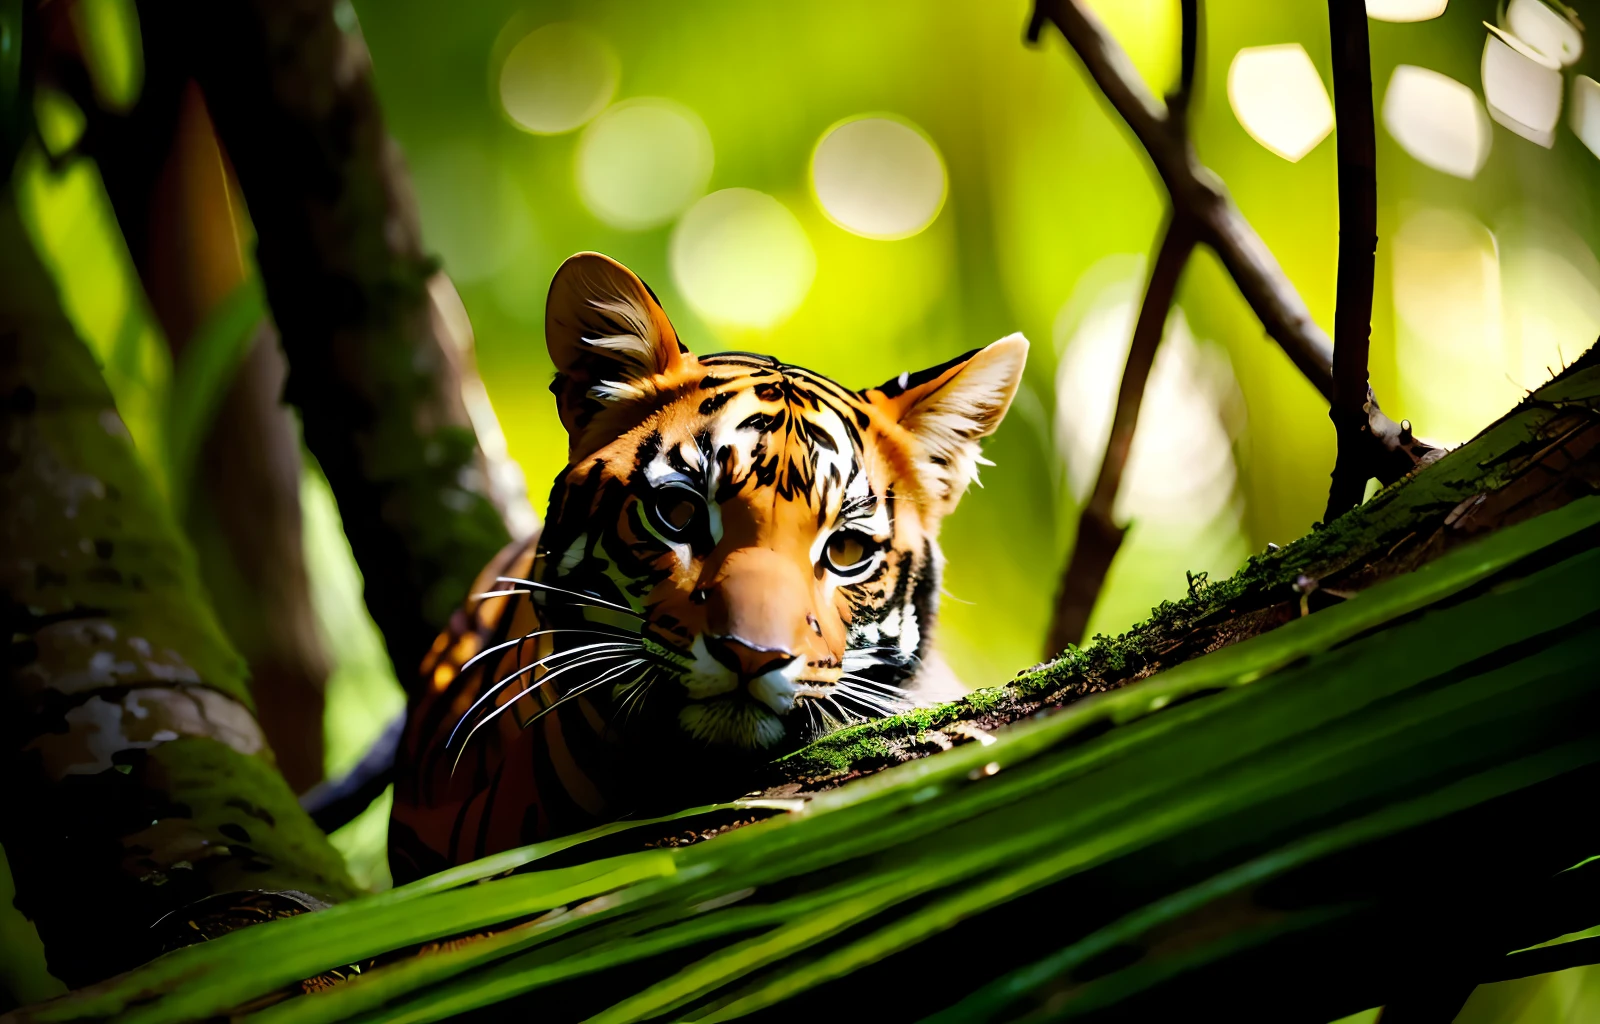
[1323,0,1378,522]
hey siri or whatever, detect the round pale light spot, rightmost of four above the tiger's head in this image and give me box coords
[811,117,947,238]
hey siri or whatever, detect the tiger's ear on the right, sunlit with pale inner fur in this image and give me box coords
[866,334,1027,515]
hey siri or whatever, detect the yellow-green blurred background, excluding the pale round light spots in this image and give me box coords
[18,0,1600,1021]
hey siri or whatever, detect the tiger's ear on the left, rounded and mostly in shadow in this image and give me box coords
[544,253,683,435]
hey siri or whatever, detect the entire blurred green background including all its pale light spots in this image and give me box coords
[16,0,1600,992]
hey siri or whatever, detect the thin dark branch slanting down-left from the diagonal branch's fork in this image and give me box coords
[1048,216,1195,654]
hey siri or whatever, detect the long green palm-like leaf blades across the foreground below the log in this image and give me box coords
[32,498,1600,1024]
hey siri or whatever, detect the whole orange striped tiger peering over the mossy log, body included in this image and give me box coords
[389,253,1027,882]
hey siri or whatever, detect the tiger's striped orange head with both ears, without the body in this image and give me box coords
[530,253,1027,752]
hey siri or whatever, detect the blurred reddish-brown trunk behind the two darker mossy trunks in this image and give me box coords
[61,32,330,792]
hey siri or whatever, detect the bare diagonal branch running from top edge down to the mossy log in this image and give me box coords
[1029,0,1442,505]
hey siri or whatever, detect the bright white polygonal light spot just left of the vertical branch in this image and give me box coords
[1227,43,1333,163]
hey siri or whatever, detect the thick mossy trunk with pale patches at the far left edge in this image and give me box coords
[0,195,355,986]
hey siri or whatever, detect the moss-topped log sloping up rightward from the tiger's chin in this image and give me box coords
[763,336,1600,797]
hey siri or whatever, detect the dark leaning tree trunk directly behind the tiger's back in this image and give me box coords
[141,0,536,697]
